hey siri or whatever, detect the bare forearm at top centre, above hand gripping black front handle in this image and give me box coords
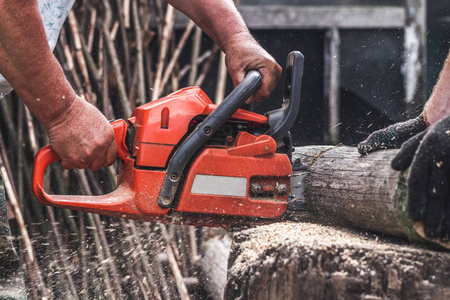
[167,0,250,53]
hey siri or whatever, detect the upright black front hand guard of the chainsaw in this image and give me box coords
[265,51,305,146]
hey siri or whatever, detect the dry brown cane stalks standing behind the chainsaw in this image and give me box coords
[0,0,224,299]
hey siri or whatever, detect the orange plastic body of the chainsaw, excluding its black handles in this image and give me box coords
[33,87,292,226]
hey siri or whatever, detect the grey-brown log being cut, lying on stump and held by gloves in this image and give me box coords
[293,146,450,249]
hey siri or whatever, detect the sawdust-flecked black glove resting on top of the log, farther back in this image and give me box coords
[358,114,427,154]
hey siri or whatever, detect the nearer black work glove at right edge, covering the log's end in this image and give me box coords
[392,117,450,240]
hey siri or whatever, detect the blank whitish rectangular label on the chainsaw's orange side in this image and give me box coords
[191,174,247,197]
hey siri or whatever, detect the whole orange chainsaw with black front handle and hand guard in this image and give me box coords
[33,51,304,229]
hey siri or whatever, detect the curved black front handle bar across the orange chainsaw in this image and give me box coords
[157,71,262,208]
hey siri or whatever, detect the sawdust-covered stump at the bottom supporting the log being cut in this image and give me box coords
[225,223,450,300]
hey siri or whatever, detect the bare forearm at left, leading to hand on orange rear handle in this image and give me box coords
[0,0,75,127]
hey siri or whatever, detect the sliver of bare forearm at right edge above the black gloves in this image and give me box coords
[425,52,450,125]
